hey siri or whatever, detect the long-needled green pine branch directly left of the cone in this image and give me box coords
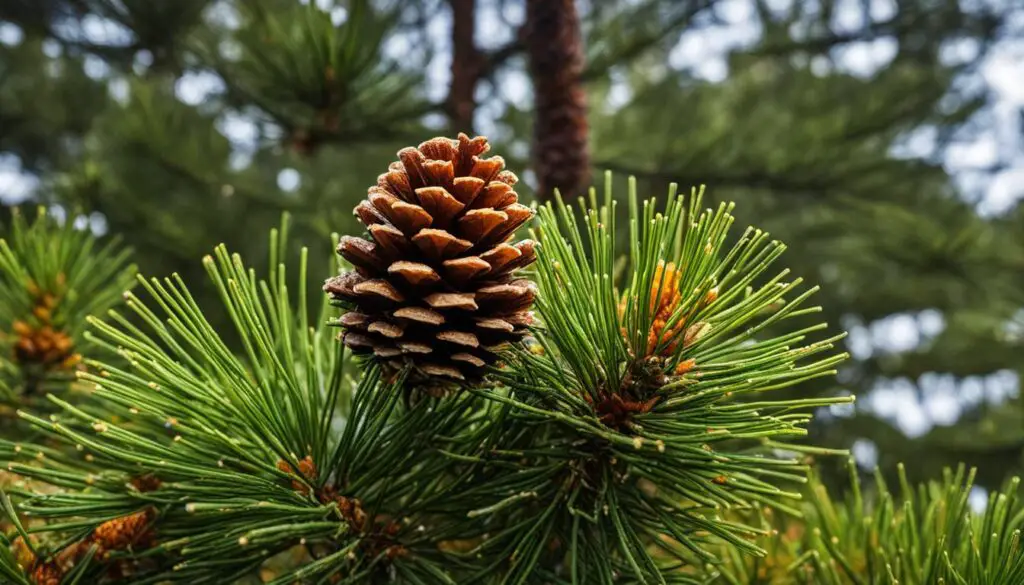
[0,215,497,584]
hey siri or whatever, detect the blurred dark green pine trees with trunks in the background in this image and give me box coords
[0,0,1024,493]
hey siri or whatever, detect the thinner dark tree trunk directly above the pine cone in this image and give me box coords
[445,0,483,133]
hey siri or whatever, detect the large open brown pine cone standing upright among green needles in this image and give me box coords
[324,134,536,381]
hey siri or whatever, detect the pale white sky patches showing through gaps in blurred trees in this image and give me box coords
[0,0,1024,456]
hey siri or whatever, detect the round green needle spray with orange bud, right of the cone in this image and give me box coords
[480,173,850,583]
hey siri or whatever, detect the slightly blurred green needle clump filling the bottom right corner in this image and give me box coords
[711,461,1024,585]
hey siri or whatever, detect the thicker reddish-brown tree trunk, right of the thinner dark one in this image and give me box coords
[525,0,590,200]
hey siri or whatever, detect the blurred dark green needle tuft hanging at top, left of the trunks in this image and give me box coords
[197,0,425,154]
